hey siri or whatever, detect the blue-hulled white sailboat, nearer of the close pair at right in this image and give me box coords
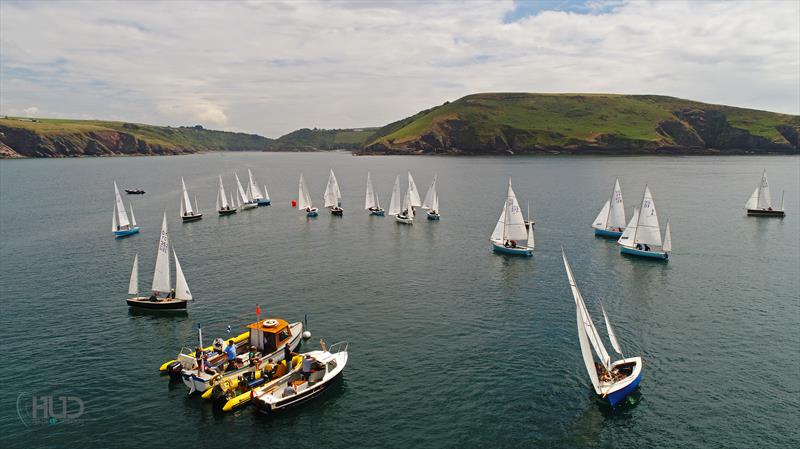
[617,186,672,260]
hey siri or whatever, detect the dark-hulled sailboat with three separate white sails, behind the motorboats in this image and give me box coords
[128,212,192,311]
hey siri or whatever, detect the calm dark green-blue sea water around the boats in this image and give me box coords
[0,153,800,448]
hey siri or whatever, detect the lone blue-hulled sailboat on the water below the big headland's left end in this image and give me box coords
[489,179,534,256]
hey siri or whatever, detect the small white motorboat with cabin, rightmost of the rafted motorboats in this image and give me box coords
[253,341,348,414]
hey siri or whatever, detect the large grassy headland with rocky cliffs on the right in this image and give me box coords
[361,93,800,154]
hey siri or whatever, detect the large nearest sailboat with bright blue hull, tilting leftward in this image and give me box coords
[561,249,642,407]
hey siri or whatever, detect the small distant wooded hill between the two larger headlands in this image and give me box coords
[270,128,377,151]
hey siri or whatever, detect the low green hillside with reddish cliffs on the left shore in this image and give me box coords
[0,118,272,157]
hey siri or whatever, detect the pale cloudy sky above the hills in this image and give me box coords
[0,0,800,137]
